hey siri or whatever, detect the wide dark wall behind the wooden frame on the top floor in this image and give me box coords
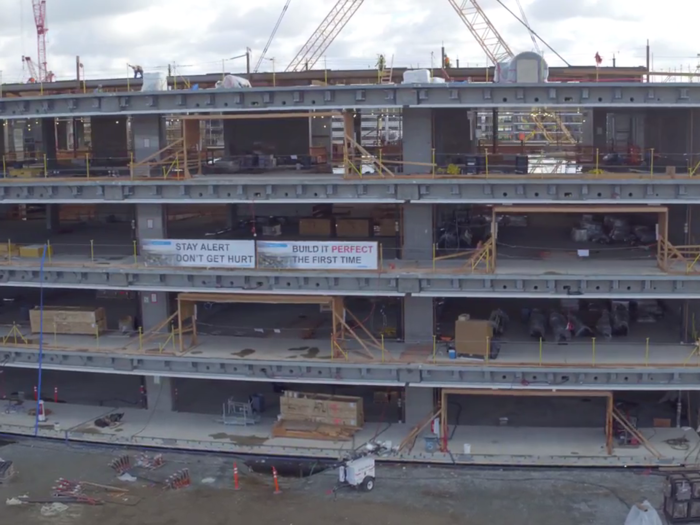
[224,118,312,156]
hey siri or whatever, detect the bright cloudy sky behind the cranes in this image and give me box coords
[0,0,700,82]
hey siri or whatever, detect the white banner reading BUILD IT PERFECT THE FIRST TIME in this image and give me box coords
[257,241,379,270]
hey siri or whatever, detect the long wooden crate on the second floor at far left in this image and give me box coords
[29,306,107,335]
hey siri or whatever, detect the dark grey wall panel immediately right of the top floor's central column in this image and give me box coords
[433,108,473,161]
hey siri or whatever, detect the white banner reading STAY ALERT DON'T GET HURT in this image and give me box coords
[141,239,255,268]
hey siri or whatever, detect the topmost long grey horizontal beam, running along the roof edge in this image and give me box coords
[0,82,700,120]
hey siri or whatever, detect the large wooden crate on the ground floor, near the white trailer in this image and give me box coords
[280,390,365,428]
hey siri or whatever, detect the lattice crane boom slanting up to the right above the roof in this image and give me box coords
[285,0,365,72]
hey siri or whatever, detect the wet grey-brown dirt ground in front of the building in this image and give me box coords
[0,440,663,525]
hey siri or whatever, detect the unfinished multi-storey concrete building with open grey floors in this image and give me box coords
[0,74,700,465]
